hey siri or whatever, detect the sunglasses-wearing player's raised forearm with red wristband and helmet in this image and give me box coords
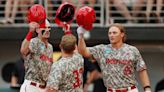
[20,4,46,56]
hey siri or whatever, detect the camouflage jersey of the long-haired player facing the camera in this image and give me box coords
[89,44,146,89]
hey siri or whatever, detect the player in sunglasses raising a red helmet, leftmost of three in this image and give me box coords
[20,5,53,92]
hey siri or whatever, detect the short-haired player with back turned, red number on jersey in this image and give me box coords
[46,31,84,92]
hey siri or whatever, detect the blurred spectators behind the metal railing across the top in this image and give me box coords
[0,0,164,24]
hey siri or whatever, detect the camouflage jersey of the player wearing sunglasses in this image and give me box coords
[24,37,53,84]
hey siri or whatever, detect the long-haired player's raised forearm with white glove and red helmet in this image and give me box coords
[76,6,96,58]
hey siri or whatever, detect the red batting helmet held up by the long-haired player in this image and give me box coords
[76,6,96,30]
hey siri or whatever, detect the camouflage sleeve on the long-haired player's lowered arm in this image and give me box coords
[133,47,146,71]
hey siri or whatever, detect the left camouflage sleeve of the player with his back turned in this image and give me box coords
[47,62,62,90]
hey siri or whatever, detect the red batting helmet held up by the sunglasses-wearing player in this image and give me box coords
[27,4,46,28]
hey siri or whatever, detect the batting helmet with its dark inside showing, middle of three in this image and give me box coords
[55,2,75,27]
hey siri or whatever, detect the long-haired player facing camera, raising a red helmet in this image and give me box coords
[77,6,151,92]
